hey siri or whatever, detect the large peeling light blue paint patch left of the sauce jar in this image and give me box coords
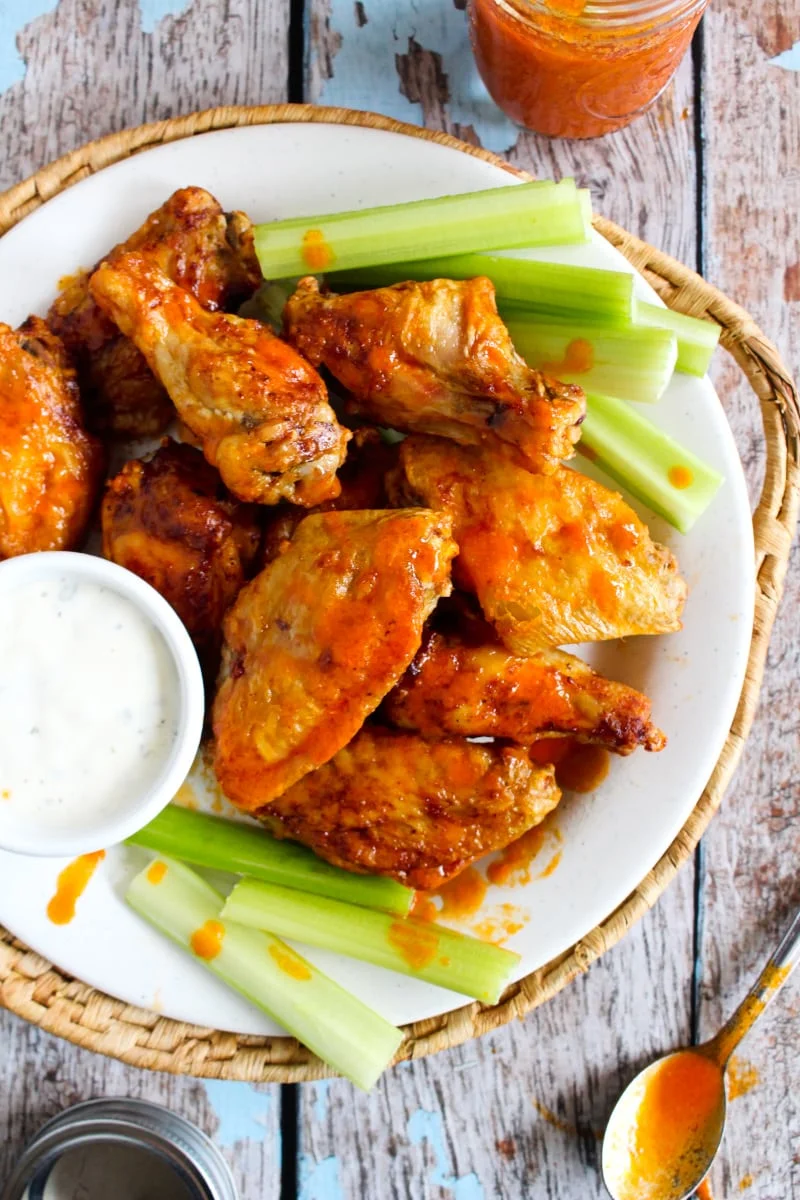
[311,0,519,151]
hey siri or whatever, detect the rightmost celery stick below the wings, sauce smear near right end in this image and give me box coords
[223,880,519,1004]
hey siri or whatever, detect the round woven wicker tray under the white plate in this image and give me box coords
[0,104,800,1082]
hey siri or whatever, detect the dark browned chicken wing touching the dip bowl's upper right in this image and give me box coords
[102,439,260,667]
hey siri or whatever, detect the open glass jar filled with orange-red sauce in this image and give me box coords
[469,0,708,138]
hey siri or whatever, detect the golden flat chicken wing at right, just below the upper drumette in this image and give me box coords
[389,437,686,655]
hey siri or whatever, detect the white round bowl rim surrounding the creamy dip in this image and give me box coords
[0,551,205,858]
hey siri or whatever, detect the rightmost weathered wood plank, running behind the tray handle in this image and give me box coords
[700,0,800,1200]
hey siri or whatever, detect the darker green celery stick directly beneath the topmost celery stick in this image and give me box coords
[326,254,633,328]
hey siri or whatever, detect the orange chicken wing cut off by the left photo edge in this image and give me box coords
[0,317,104,559]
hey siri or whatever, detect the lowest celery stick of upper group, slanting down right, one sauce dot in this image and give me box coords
[578,394,723,533]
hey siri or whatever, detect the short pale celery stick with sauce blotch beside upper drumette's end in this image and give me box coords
[500,306,678,403]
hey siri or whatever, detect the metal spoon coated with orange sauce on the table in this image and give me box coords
[602,912,800,1200]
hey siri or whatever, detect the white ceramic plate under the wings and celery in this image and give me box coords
[0,125,753,1033]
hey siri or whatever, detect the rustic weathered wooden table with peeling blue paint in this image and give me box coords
[0,0,800,1200]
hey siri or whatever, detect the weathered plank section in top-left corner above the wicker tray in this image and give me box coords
[0,0,289,188]
